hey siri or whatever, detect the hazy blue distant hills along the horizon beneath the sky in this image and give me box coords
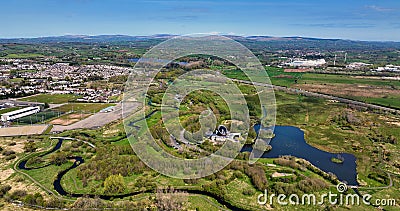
[0,34,400,50]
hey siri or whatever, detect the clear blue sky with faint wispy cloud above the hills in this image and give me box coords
[0,0,400,41]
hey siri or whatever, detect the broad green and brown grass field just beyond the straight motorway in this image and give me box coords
[222,67,400,109]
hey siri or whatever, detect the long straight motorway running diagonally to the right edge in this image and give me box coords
[232,79,400,114]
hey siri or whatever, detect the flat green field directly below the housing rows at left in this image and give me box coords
[20,94,79,104]
